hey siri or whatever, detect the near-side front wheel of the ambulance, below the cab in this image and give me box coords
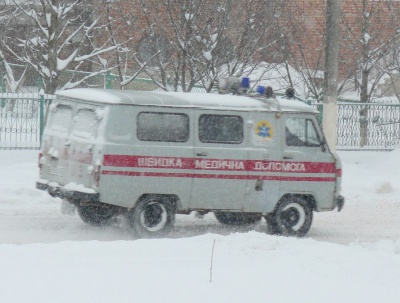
[272,197,313,237]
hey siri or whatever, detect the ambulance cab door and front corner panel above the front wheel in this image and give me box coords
[281,114,336,210]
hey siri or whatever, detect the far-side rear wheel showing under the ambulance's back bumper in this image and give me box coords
[77,205,115,226]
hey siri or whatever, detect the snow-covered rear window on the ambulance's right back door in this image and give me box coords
[72,109,98,138]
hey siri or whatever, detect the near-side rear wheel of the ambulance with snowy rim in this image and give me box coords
[127,196,175,238]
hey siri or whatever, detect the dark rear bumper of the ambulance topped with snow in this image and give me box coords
[36,180,100,202]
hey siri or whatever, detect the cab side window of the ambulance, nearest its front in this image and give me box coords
[285,118,321,146]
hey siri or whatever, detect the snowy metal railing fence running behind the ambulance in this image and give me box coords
[0,86,400,150]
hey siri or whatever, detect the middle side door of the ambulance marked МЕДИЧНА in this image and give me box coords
[190,110,247,210]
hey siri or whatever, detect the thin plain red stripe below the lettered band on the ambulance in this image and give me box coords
[102,170,336,182]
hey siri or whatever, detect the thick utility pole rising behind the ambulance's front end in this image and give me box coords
[322,0,340,151]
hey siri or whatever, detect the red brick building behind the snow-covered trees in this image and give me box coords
[103,0,400,87]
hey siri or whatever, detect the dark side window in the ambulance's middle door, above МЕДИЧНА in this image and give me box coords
[199,115,243,144]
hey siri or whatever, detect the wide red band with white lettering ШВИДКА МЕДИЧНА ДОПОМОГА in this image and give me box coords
[103,155,336,174]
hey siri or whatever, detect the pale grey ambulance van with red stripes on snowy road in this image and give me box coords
[36,89,344,237]
